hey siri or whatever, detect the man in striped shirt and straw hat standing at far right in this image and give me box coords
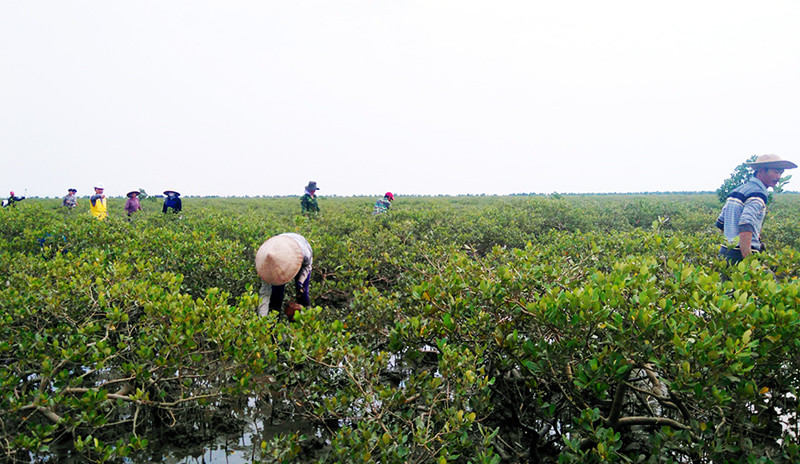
[716,155,797,264]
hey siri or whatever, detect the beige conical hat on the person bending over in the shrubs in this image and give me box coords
[256,235,303,285]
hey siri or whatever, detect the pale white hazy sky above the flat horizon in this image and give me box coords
[0,0,800,196]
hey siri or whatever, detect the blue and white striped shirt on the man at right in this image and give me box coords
[716,177,767,251]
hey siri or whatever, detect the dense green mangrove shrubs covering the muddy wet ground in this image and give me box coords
[0,194,800,463]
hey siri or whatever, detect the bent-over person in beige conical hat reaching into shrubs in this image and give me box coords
[256,233,314,322]
